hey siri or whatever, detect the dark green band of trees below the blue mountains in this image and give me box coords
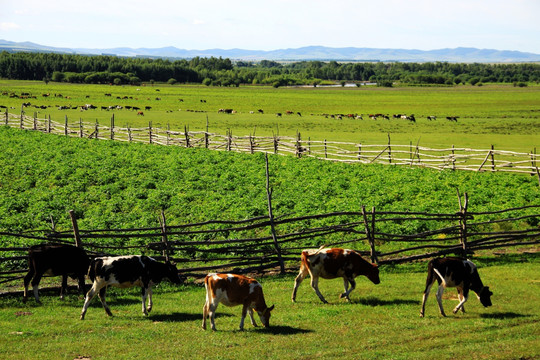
[0,52,540,87]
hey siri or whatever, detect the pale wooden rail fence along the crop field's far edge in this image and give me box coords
[4,110,540,177]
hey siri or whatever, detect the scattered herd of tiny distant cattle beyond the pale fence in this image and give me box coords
[0,89,459,123]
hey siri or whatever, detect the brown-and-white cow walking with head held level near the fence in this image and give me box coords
[292,247,381,304]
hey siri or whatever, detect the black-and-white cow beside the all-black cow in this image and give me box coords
[81,255,181,320]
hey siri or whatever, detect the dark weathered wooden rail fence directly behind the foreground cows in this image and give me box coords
[0,192,540,294]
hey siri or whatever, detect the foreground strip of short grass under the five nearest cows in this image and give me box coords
[0,255,540,360]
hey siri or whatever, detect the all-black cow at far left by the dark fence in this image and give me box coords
[23,244,90,303]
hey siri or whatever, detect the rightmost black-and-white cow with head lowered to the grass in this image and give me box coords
[420,257,493,317]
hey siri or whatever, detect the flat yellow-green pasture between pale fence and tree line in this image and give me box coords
[0,80,540,152]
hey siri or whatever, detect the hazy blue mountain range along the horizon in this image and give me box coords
[0,40,540,63]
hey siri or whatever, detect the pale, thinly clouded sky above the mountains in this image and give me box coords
[0,0,540,54]
